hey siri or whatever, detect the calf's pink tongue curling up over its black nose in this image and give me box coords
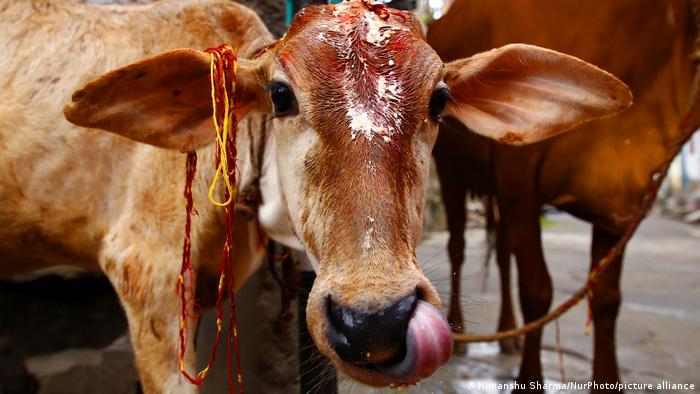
[377,301,452,383]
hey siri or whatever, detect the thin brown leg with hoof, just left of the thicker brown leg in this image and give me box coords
[496,223,520,354]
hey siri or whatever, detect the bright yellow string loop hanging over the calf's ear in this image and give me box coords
[209,53,238,207]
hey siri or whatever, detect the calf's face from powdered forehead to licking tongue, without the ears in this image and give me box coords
[263,2,451,385]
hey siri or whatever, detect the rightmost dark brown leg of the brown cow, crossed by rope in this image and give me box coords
[590,226,622,383]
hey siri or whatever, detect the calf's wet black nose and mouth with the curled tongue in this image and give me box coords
[326,292,452,385]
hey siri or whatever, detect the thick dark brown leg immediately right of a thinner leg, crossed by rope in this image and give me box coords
[502,208,552,392]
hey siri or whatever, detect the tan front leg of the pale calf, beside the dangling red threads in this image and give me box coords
[101,244,197,394]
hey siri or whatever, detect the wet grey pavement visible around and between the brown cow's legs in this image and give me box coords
[340,214,700,393]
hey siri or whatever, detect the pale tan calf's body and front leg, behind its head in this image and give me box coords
[0,1,272,392]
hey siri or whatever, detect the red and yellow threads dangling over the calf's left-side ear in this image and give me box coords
[177,45,243,393]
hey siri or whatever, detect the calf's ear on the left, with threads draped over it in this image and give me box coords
[63,49,269,151]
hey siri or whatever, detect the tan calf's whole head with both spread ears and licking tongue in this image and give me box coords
[66,1,631,385]
